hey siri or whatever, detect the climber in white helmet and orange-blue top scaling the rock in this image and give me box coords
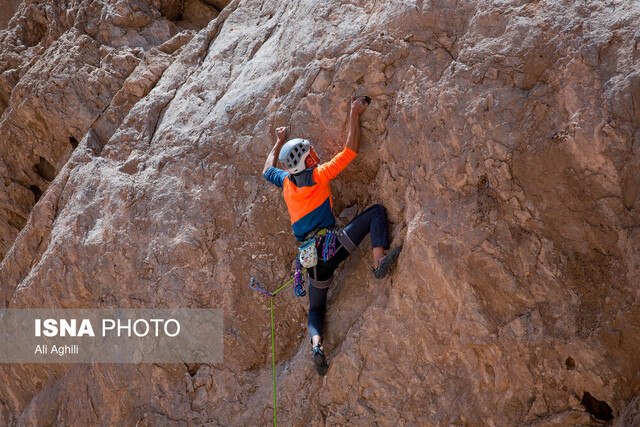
[262,96,401,375]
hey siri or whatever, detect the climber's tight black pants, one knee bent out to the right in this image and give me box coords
[307,205,389,336]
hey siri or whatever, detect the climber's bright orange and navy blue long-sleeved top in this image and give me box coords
[264,148,356,241]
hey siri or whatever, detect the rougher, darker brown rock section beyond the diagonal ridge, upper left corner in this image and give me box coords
[0,0,218,257]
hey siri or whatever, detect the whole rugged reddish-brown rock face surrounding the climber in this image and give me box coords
[0,0,640,425]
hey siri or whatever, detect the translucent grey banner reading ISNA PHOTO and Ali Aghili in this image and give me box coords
[0,308,223,363]
